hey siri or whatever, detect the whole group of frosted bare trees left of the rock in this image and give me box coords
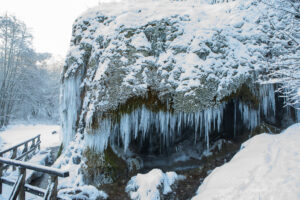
[0,15,60,128]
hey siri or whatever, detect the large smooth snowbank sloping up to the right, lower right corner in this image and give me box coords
[193,123,300,200]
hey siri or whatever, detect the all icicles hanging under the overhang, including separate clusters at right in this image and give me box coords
[85,85,282,152]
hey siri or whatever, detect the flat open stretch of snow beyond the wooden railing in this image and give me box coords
[0,124,61,150]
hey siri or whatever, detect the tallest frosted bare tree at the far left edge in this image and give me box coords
[0,15,31,127]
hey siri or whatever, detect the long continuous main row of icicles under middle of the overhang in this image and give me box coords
[83,101,225,152]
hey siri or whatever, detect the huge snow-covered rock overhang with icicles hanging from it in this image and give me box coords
[61,0,300,186]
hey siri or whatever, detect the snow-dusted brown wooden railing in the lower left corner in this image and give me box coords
[0,135,69,200]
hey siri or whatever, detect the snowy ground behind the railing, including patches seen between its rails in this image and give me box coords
[0,125,61,200]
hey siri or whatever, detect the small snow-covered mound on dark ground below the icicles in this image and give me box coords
[126,169,185,200]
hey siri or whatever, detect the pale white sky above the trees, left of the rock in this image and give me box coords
[0,0,103,57]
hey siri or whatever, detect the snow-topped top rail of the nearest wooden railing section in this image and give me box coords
[0,158,69,177]
